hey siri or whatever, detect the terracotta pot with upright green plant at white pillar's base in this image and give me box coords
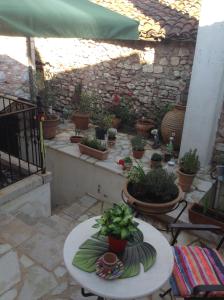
[177,149,200,192]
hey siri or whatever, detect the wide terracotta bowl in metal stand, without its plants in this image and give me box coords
[122,182,183,215]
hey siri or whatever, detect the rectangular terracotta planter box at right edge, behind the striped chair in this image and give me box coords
[188,203,224,229]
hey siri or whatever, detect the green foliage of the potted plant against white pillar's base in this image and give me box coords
[179,149,200,174]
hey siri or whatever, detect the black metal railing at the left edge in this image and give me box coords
[0,94,44,189]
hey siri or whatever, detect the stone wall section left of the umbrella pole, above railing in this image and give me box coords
[0,36,30,99]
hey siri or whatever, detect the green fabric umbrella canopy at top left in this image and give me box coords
[0,0,139,40]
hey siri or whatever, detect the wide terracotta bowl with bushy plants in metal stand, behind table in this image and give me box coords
[123,165,182,214]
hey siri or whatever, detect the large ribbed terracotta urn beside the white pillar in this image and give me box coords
[161,105,186,150]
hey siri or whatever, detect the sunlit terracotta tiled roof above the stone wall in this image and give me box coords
[91,0,201,41]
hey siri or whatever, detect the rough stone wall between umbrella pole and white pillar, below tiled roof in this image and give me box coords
[35,39,195,117]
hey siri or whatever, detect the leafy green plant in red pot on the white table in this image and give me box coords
[93,203,138,253]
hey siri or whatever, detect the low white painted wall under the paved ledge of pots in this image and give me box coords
[46,147,125,206]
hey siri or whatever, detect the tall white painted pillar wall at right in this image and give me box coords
[180,0,224,168]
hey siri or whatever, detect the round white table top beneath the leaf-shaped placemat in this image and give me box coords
[64,217,174,299]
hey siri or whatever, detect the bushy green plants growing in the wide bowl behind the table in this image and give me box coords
[128,169,179,203]
